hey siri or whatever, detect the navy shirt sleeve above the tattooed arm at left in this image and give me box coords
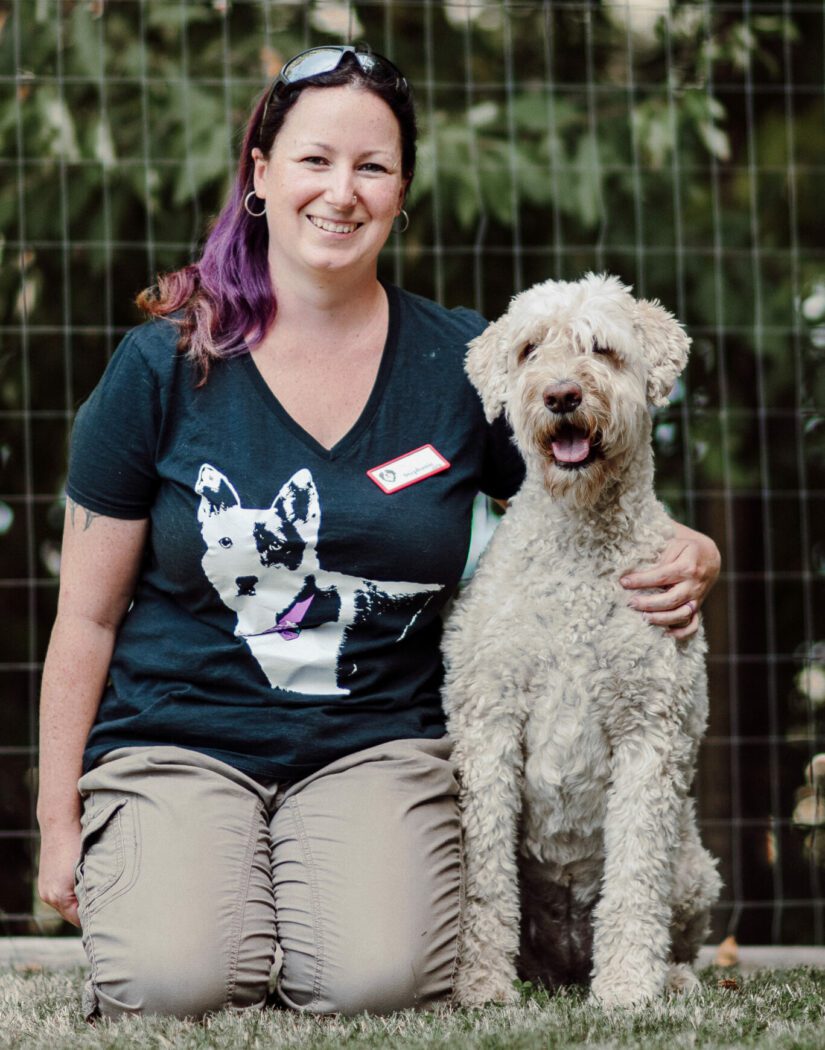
[66,327,161,520]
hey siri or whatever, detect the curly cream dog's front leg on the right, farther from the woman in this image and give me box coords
[592,727,688,1006]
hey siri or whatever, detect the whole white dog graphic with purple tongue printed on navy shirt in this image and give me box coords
[195,463,442,696]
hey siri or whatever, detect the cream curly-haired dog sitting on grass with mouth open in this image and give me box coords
[444,274,719,1006]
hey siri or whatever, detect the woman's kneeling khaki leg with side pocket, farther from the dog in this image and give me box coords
[77,748,275,1017]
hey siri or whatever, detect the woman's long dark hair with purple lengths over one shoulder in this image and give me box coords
[136,53,418,382]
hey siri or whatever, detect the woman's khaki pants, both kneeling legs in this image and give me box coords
[77,738,461,1016]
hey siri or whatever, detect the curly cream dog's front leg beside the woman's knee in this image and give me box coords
[450,709,523,1006]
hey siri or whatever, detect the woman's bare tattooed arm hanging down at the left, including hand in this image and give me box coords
[37,500,148,926]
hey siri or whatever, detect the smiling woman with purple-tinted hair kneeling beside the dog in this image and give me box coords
[38,47,718,1016]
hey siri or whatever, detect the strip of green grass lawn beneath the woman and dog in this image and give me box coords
[0,967,825,1050]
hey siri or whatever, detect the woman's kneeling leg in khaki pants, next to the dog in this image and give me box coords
[271,740,461,1014]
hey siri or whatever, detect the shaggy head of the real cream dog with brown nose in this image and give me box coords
[466,273,690,503]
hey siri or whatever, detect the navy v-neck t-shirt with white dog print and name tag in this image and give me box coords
[66,286,523,781]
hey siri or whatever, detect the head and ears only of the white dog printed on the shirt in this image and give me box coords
[195,463,320,636]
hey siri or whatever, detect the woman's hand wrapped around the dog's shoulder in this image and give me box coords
[620,522,722,638]
